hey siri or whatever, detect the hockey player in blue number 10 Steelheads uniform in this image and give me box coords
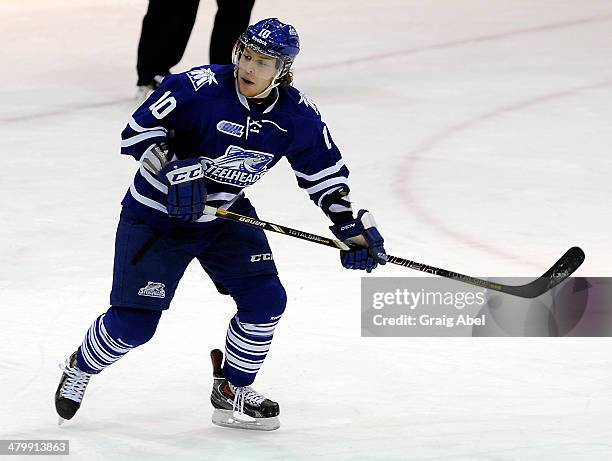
[55,18,386,430]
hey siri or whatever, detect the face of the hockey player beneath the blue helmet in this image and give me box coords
[238,48,277,98]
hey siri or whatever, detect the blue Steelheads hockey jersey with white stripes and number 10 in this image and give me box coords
[121,65,349,229]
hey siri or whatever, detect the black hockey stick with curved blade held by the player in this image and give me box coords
[204,206,584,298]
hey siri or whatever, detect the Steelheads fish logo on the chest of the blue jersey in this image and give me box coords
[202,146,274,187]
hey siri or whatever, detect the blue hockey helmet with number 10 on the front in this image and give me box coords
[232,18,300,79]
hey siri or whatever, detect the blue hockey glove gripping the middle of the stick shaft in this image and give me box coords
[329,210,387,272]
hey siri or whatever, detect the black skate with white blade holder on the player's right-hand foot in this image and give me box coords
[210,349,280,431]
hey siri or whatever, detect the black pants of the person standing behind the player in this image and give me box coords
[136,0,255,85]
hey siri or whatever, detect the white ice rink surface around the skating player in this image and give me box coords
[0,0,612,461]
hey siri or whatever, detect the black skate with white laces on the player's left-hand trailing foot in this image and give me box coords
[55,352,92,424]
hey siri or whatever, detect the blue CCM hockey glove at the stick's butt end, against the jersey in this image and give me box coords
[161,158,206,222]
